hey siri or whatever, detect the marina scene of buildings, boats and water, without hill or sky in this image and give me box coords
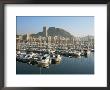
[16,27,95,74]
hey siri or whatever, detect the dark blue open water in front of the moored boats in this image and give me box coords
[16,53,94,75]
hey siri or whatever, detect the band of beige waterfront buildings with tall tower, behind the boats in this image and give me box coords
[16,26,94,49]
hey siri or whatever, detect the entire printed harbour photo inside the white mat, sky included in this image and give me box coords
[16,16,95,74]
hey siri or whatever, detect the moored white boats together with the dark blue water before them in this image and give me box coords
[16,48,94,74]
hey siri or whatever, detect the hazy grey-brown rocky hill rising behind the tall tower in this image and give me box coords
[32,27,72,37]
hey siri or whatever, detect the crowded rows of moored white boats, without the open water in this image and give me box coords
[16,49,93,64]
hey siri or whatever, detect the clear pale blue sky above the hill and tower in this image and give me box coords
[16,16,94,36]
